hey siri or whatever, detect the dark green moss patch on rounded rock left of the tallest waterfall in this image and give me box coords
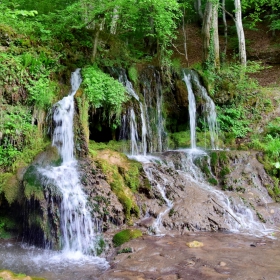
[23,165,44,200]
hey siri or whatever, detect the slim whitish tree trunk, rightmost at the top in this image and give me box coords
[234,0,247,66]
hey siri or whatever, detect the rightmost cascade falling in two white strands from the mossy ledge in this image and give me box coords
[183,70,219,150]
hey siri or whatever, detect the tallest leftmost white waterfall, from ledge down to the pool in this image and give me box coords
[38,69,100,255]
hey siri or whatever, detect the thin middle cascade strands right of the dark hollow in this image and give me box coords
[118,68,165,156]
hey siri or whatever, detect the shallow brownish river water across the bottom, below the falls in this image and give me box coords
[0,232,280,280]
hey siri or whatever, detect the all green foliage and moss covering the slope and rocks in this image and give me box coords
[0,0,280,242]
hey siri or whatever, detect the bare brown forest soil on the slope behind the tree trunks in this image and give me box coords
[173,21,280,87]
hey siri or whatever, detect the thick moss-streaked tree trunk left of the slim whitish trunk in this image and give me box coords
[202,0,220,69]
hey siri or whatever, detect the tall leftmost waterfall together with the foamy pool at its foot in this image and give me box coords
[0,69,108,280]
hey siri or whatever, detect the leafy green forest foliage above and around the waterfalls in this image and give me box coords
[0,0,280,199]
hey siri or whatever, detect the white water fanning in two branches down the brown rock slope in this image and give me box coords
[138,149,273,236]
